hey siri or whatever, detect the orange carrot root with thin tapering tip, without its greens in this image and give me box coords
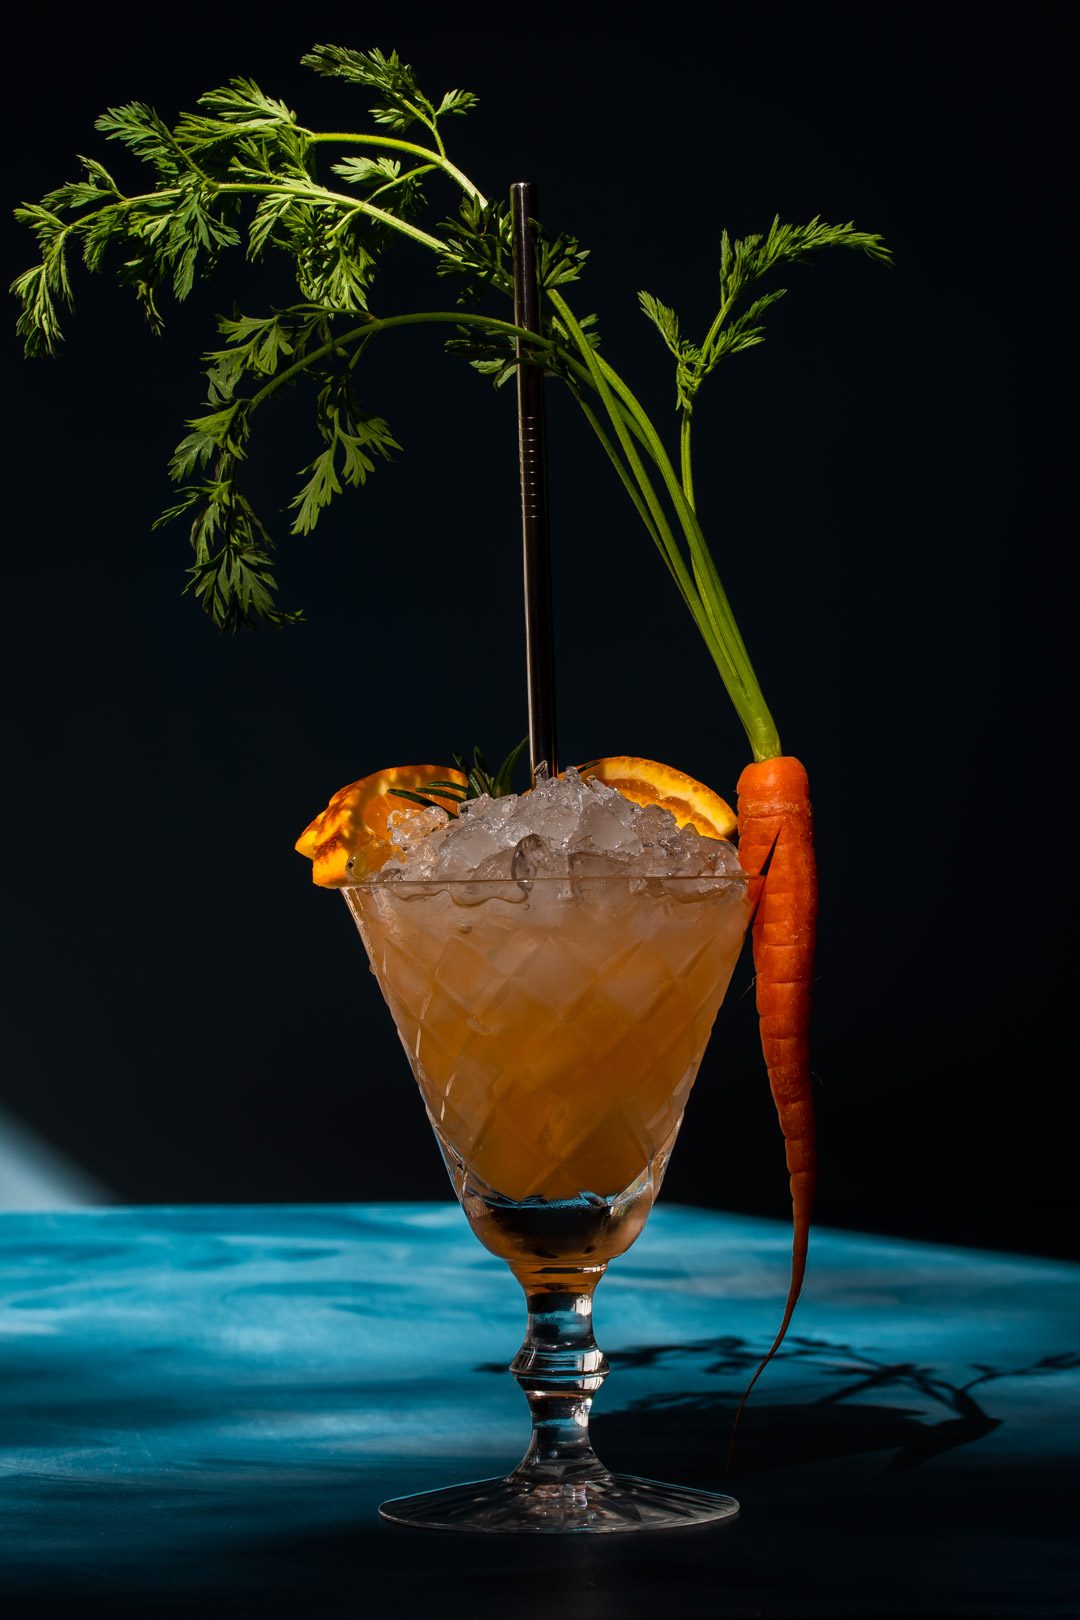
[735,755,818,1424]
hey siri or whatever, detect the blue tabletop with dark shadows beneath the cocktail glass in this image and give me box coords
[0,1204,1080,1620]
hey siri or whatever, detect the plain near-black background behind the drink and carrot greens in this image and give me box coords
[0,5,1075,1252]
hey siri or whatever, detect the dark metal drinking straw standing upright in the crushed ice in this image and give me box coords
[510,180,559,781]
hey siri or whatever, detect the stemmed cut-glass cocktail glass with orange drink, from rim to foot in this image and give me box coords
[343,876,748,1531]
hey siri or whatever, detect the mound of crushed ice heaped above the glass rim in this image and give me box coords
[379,766,742,883]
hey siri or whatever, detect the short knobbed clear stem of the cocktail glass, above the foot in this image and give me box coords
[510,1280,607,1484]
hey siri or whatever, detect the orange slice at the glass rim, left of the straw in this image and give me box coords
[296,765,466,889]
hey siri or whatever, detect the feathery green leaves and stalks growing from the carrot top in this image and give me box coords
[11,45,889,760]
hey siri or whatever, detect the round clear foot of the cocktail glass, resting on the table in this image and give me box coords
[379,1474,738,1534]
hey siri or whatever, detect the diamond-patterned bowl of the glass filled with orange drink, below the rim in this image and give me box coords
[343,876,746,1275]
